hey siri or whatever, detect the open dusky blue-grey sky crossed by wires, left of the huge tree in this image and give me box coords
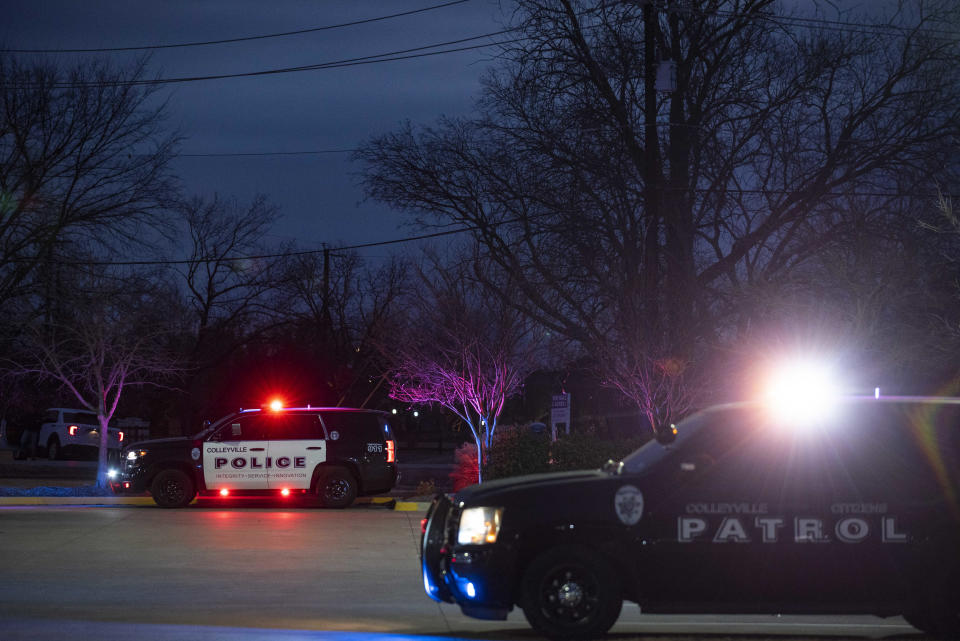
[0,0,502,255]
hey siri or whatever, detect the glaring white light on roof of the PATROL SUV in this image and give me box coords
[764,361,841,425]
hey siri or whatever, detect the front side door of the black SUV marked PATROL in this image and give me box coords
[634,414,787,611]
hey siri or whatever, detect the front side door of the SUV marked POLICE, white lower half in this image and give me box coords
[202,413,270,490]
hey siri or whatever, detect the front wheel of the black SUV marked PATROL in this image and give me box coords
[521,546,623,639]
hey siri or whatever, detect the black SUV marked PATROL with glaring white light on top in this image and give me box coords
[421,397,960,638]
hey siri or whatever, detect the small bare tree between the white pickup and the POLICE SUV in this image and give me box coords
[4,268,183,487]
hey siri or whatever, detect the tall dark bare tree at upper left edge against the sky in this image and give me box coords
[0,54,178,307]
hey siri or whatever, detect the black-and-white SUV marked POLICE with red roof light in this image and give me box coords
[114,407,399,508]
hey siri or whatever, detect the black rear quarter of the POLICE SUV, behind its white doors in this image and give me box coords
[322,411,396,491]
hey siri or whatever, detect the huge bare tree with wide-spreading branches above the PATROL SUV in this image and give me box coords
[358,0,960,425]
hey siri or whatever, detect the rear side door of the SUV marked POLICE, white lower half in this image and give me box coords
[263,412,327,489]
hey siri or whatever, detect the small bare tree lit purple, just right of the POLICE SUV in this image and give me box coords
[383,258,541,481]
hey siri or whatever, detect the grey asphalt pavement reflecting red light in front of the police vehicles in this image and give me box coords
[0,507,914,641]
